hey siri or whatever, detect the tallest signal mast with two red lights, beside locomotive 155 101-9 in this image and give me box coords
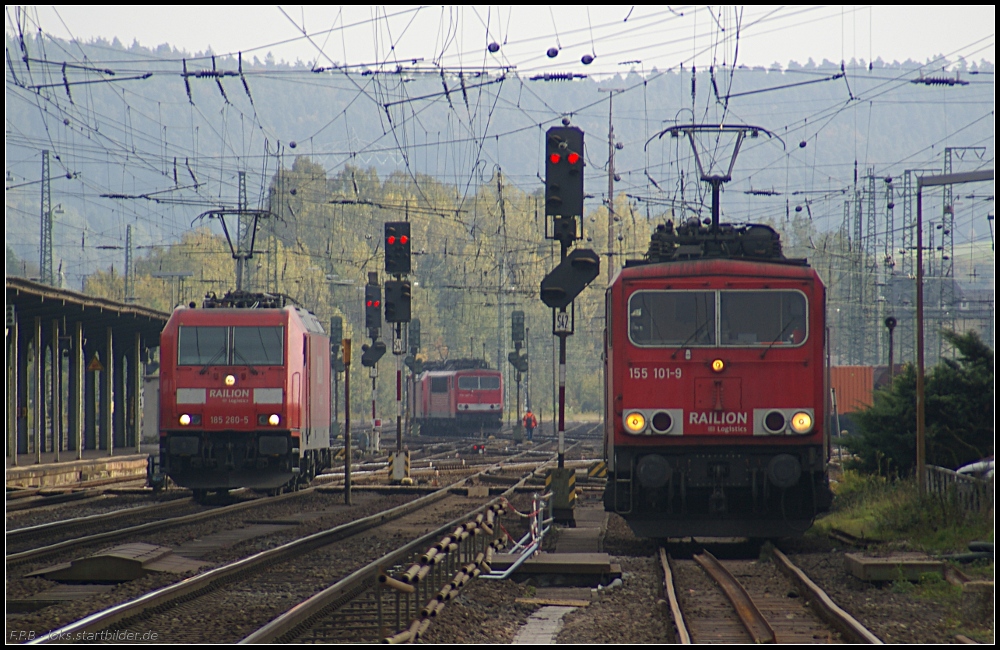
[541,123,601,522]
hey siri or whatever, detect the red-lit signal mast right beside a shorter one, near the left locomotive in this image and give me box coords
[384,221,412,482]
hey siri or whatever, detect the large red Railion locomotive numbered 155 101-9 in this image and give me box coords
[604,219,832,537]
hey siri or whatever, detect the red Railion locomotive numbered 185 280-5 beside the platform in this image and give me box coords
[160,292,331,493]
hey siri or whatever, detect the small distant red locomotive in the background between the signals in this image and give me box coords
[410,359,503,435]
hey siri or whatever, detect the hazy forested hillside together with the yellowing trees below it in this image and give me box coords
[5,37,994,419]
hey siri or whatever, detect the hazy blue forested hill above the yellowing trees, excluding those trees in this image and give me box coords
[5,35,994,286]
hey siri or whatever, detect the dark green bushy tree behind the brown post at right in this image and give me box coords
[844,331,994,475]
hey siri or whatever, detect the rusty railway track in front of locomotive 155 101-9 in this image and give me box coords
[659,547,881,644]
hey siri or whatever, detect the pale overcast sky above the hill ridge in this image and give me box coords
[17,5,996,74]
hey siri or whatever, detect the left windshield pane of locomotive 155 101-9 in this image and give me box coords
[628,291,715,347]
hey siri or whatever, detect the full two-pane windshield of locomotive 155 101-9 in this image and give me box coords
[629,290,808,347]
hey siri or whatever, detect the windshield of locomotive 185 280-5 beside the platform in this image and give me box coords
[177,326,285,366]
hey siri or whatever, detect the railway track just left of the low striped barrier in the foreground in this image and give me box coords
[25,442,572,643]
